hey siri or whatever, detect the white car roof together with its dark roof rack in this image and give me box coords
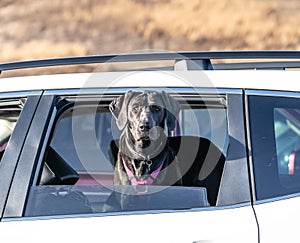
[0,51,300,92]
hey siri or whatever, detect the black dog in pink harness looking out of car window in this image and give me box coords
[109,90,182,189]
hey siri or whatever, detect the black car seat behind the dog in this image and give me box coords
[109,136,225,205]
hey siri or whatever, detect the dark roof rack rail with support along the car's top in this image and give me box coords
[0,51,300,73]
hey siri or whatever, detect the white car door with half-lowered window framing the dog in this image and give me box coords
[1,88,258,242]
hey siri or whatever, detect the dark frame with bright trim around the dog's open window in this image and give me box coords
[4,88,251,220]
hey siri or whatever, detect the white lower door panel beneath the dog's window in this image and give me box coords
[0,205,258,243]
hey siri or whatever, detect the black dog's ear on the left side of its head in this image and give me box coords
[109,91,133,130]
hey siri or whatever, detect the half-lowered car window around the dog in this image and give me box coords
[25,92,228,216]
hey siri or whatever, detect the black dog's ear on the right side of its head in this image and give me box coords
[161,91,180,130]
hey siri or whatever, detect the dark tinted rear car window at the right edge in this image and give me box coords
[249,96,300,199]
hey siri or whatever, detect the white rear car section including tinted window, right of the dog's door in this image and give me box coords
[247,91,300,243]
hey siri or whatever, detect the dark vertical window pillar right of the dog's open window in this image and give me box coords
[217,89,253,208]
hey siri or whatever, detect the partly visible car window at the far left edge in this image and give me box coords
[0,99,25,161]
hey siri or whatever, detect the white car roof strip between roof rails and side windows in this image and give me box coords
[0,70,300,92]
